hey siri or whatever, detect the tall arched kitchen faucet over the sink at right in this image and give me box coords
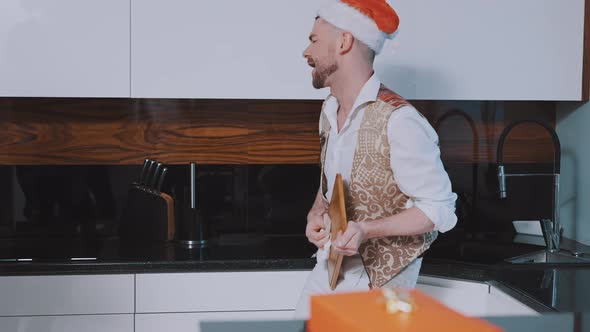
[497,120,563,252]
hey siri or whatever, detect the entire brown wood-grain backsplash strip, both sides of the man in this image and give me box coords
[0,98,555,165]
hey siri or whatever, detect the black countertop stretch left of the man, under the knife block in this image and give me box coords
[0,236,315,276]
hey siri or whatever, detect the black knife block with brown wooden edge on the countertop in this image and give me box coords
[119,184,175,242]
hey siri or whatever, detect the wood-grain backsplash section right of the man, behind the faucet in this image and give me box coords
[413,101,555,163]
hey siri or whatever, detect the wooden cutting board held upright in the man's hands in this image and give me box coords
[328,174,347,289]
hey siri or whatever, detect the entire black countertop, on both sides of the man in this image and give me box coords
[0,235,590,312]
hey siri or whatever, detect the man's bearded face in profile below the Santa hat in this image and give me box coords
[303,18,338,89]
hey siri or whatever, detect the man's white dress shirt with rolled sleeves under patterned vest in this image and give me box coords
[320,74,457,232]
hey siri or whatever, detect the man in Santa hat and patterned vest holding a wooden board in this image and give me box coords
[296,0,457,318]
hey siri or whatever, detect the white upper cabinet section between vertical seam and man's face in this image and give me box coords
[131,0,328,99]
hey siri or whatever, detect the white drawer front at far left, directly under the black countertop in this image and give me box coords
[0,275,134,316]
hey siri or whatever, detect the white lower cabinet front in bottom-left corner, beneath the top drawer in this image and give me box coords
[0,314,133,332]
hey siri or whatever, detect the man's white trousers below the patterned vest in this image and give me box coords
[294,255,422,320]
